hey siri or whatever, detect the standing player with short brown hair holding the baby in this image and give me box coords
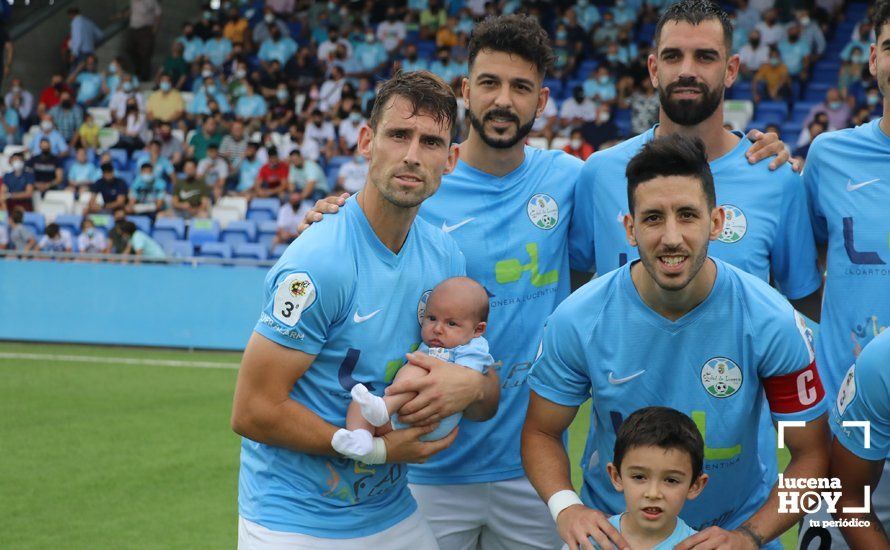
[232,72,498,550]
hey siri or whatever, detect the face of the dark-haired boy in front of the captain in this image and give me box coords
[607,446,708,536]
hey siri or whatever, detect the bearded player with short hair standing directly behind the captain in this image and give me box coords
[570,0,822,321]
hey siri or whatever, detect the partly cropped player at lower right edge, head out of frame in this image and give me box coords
[829,331,890,548]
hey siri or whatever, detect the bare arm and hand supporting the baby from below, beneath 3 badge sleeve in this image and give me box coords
[232,333,457,462]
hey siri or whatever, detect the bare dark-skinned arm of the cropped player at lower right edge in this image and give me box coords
[828,438,890,548]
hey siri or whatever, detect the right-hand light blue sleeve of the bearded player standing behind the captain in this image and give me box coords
[770,168,822,300]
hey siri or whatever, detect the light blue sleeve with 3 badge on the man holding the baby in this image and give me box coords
[254,244,354,355]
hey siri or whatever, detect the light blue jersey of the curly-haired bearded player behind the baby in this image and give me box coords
[409,147,581,484]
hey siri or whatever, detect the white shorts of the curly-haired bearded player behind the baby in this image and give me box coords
[408,477,562,550]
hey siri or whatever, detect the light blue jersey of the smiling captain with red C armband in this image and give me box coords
[529,259,825,540]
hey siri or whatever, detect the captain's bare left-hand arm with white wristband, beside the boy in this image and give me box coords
[522,390,630,550]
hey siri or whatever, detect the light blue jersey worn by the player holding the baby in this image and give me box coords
[238,198,465,538]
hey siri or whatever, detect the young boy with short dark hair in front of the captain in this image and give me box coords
[606,407,708,550]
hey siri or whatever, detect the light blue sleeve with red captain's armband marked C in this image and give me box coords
[758,303,827,421]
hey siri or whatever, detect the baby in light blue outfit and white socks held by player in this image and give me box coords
[332,277,494,455]
